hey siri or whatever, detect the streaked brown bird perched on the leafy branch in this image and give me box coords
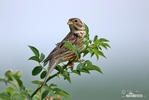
[42,18,86,86]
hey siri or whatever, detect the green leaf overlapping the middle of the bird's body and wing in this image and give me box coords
[64,41,81,58]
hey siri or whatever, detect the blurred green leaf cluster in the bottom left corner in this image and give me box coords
[0,70,31,100]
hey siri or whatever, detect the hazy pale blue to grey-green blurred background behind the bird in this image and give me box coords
[0,0,149,100]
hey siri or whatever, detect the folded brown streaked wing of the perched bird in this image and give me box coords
[44,32,78,62]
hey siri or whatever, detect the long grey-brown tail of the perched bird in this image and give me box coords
[41,60,57,87]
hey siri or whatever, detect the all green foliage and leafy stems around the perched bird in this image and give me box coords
[0,25,110,100]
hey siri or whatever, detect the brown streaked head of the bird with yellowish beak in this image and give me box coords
[67,18,85,32]
